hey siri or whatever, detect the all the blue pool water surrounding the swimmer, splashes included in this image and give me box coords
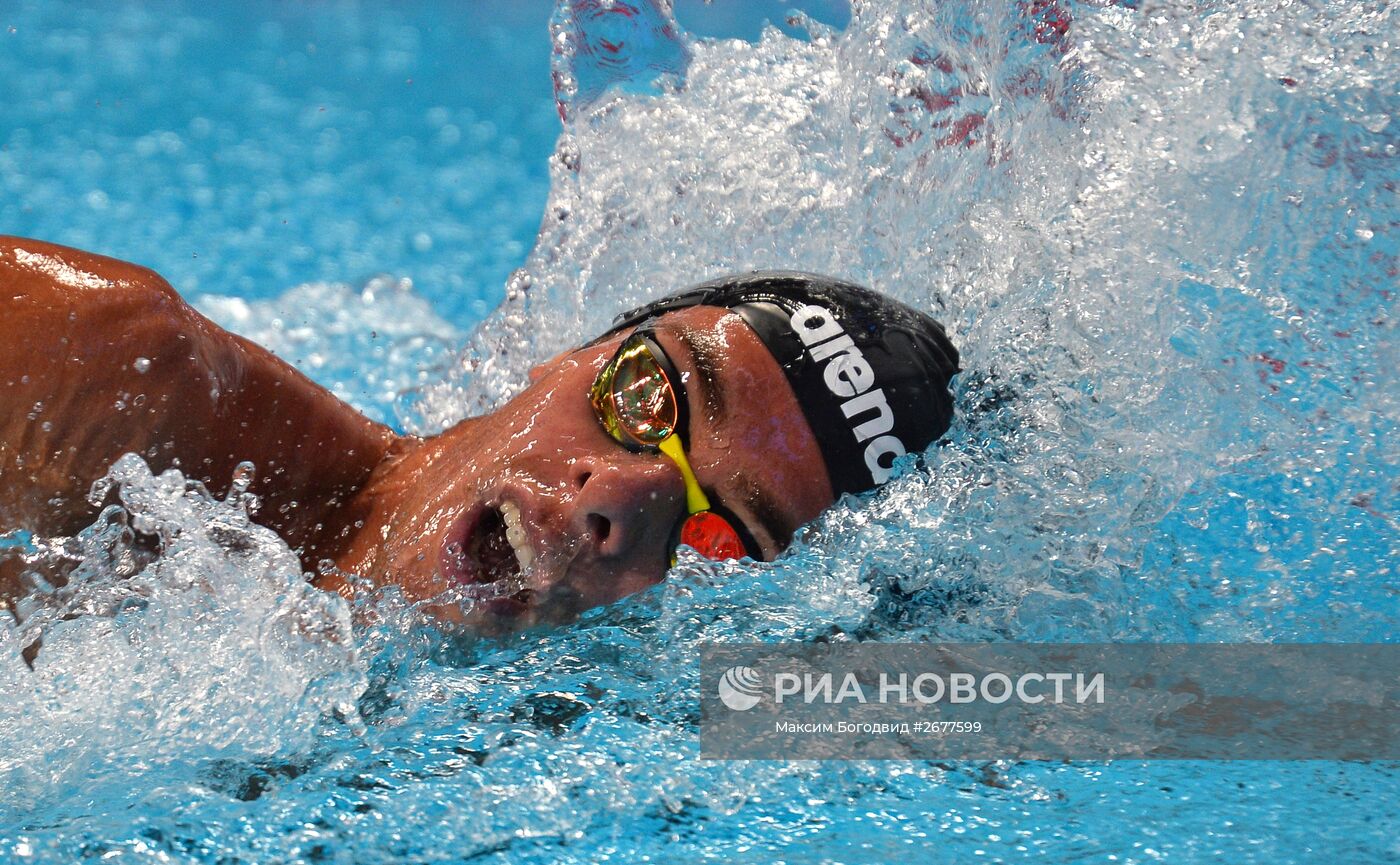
[0,0,1400,864]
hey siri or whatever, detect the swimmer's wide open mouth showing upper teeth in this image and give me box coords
[442,501,536,614]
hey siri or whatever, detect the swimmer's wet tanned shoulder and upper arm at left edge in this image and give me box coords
[0,237,393,557]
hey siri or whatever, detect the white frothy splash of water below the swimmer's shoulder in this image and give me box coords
[0,455,365,808]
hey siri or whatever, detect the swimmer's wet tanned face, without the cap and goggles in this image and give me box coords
[327,307,833,630]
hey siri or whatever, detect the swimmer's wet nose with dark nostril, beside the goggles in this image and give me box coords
[562,453,685,558]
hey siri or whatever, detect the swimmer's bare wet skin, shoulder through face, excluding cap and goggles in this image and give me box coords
[0,238,833,631]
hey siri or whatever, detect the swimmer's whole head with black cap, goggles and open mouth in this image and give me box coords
[326,273,958,630]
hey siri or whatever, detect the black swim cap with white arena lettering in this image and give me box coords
[609,270,959,497]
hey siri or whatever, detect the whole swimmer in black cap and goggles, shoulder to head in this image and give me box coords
[0,237,958,631]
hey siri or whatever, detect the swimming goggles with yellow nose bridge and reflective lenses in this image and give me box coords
[589,328,759,565]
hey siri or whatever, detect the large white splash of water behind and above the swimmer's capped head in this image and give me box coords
[421,3,1400,638]
